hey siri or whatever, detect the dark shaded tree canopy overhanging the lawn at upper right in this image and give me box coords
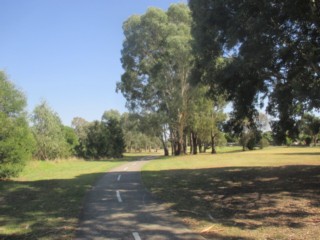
[189,0,320,141]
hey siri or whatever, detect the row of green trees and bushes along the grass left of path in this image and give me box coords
[0,71,125,179]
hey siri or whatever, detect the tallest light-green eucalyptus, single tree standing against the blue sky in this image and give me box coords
[117,4,193,154]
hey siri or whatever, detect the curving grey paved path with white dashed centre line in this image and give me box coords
[76,157,204,240]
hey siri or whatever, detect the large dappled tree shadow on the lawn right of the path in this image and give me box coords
[143,165,320,239]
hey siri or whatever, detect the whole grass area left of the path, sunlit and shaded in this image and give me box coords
[0,154,139,239]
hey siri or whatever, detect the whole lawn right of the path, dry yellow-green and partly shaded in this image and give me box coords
[142,147,320,239]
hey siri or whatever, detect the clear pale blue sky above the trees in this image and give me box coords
[0,0,187,125]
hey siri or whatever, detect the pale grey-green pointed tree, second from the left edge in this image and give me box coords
[31,102,70,160]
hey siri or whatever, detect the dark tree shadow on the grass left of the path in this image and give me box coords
[0,173,104,240]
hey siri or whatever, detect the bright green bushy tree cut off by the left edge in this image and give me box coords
[0,71,34,179]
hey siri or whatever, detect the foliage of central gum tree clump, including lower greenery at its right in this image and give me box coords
[117,4,228,155]
